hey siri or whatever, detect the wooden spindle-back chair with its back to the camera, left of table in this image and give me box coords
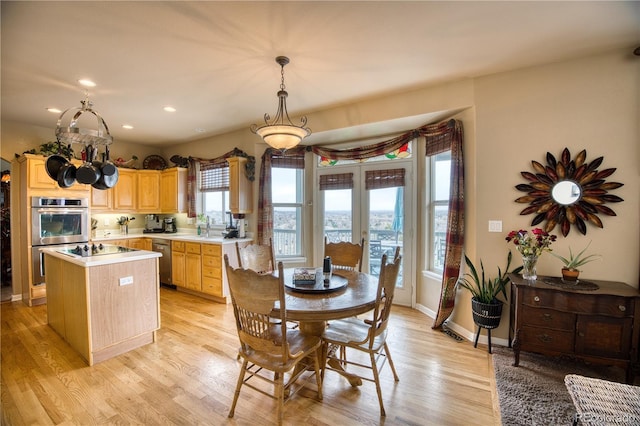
[224,254,322,424]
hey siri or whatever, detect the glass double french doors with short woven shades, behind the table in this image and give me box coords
[315,161,415,306]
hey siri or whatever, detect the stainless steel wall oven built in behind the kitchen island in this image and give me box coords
[31,197,90,285]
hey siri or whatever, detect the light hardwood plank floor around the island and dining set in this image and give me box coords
[0,288,500,426]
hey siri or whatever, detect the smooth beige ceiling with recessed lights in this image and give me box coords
[0,1,640,146]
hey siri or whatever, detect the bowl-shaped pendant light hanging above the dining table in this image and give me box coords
[251,56,311,151]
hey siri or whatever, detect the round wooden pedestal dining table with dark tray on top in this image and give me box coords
[276,268,378,386]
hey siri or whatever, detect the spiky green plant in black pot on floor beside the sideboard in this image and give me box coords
[458,250,522,329]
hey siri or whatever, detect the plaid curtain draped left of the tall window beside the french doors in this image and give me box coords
[258,146,308,245]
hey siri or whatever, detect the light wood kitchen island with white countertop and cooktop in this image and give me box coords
[42,245,161,365]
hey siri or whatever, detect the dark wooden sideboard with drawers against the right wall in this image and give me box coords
[509,274,640,383]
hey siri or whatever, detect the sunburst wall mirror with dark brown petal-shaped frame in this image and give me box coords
[516,148,624,237]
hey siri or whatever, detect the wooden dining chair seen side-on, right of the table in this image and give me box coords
[322,247,402,416]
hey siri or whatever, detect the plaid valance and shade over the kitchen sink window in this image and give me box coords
[187,148,255,217]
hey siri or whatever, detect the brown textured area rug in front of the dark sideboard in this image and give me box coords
[492,346,625,426]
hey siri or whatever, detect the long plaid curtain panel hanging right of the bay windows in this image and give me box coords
[419,119,464,328]
